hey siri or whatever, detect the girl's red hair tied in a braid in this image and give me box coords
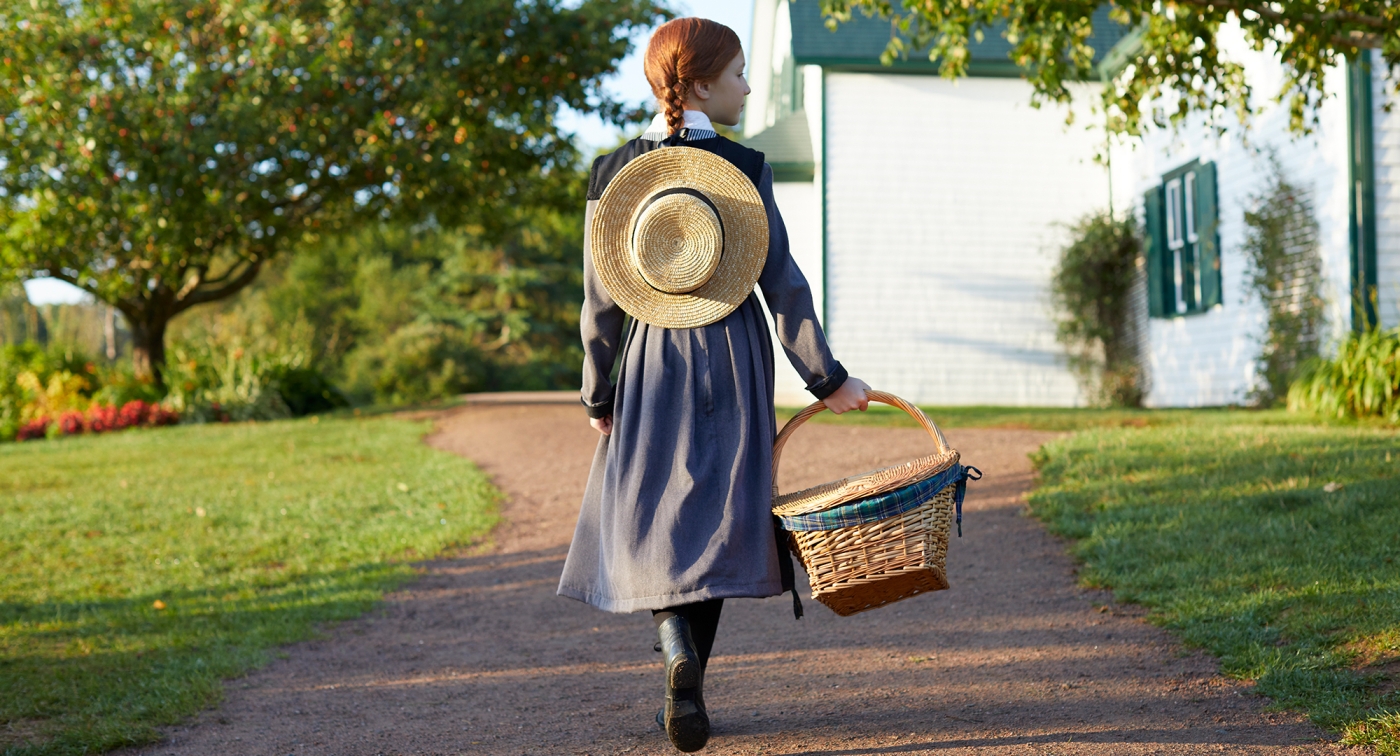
[643,18,743,134]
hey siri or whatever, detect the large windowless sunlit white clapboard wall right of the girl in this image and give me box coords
[825,73,1109,406]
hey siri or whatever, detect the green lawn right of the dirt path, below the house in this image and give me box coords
[1030,412,1400,755]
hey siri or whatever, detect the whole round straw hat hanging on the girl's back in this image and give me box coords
[589,146,769,328]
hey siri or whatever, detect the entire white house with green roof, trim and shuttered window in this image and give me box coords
[743,0,1400,406]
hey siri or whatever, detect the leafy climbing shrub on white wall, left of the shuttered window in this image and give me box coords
[1050,207,1142,407]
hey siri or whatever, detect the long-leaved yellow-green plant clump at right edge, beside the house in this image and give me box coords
[1288,328,1400,426]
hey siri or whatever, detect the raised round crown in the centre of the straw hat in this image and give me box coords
[630,192,724,294]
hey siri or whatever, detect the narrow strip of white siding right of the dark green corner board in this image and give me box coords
[1371,56,1400,328]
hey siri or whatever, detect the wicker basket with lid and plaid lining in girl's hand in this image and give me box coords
[773,391,981,616]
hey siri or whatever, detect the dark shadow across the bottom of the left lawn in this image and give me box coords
[0,564,414,756]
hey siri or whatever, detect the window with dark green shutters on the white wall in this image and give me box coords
[1145,161,1221,318]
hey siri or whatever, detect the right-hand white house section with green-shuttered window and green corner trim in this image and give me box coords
[1133,41,1400,406]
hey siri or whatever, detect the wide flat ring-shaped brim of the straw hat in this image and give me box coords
[589,147,769,328]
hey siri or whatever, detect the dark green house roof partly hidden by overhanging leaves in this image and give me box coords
[790,0,1131,76]
